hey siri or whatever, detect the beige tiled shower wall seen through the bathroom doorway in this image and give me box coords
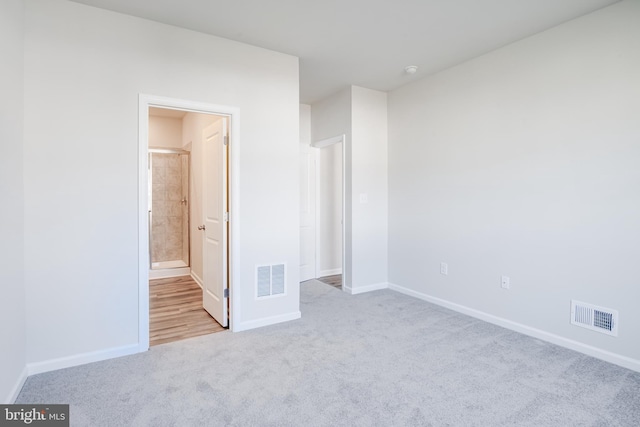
[151,153,189,266]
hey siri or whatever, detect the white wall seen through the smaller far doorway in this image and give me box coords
[316,143,342,277]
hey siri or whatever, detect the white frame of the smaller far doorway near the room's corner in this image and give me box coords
[310,134,344,292]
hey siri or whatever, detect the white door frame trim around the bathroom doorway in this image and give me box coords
[138,94,241,352]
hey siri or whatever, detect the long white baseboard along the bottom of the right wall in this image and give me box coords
[389,283,640,372]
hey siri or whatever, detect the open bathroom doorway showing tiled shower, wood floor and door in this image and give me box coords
[140,96,238,348]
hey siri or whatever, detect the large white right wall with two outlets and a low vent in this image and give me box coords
[389,1,640,369]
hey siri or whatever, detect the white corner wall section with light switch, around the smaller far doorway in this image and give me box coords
[311,86,388,293]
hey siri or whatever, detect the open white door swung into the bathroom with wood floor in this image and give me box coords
[202,119,228,327]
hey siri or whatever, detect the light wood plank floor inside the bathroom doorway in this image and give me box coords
[149,276,225,346]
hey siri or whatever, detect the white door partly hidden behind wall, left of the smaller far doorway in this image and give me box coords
[300,144,318,282]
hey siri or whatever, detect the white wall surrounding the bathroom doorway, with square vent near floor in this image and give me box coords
[24,0,299,370]
